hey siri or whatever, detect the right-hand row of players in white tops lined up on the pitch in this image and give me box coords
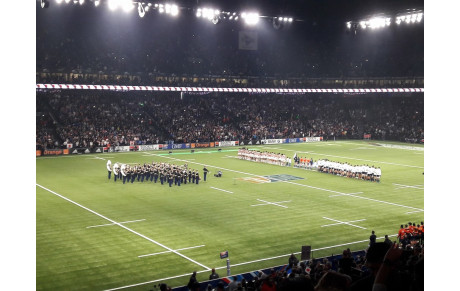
[317,159,382,182]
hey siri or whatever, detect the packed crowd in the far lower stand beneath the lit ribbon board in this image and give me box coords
[36,90,423,149]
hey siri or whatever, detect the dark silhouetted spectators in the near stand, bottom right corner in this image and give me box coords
[173,226,424,291]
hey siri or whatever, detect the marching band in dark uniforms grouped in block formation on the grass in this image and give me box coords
[107,160,201,187]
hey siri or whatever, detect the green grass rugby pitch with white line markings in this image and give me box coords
[36,141,424,290]
